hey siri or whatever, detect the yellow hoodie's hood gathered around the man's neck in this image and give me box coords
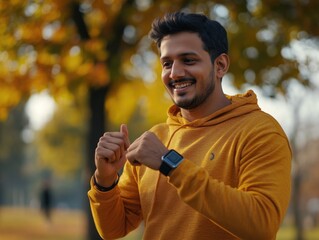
[167,90,260,127]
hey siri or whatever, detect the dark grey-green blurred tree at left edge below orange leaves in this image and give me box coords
[0,102,29,206]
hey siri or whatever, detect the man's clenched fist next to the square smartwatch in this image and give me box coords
[126,132,168,170]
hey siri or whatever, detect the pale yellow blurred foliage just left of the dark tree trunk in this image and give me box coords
[36,84,87,175]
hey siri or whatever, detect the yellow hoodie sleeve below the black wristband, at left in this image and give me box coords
[88,164,142,239]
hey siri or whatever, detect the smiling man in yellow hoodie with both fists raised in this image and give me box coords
[88,12,291,240]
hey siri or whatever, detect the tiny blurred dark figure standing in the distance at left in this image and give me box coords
[40,180,52,222]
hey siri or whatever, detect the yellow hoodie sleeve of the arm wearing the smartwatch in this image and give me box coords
[169,132,291,240]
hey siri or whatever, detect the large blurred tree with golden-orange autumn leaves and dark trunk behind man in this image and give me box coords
[0,0,319,239]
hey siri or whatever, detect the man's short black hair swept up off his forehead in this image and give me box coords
[149,12,228,62]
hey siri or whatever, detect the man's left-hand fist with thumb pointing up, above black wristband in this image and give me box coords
[95,124,130,187]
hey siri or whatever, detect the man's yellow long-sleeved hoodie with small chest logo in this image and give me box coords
[88,91,291,240]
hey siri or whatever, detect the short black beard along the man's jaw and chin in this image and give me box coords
[174,77,215,110]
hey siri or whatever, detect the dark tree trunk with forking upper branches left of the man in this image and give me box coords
[72,0,135,237]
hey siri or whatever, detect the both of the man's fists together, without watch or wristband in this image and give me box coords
[95,124,168,187]
